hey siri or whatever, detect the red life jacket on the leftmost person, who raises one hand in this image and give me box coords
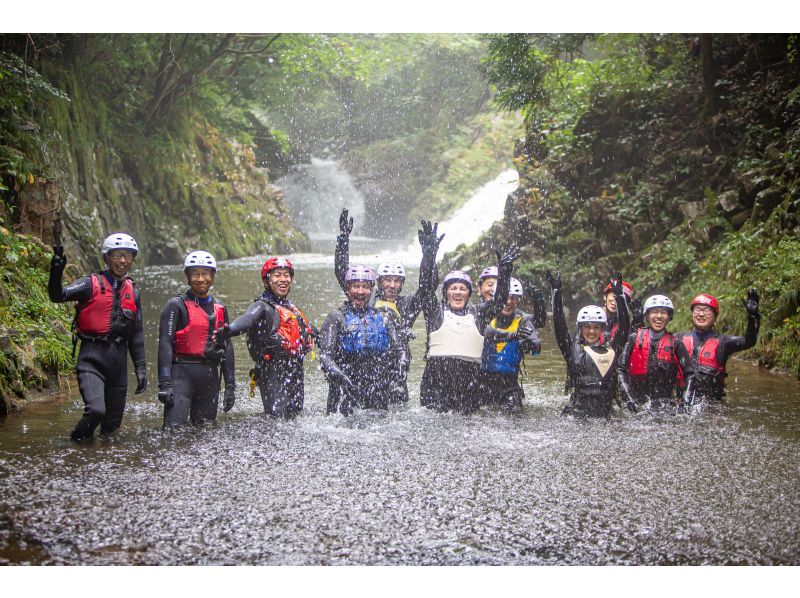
[75,274,136,336]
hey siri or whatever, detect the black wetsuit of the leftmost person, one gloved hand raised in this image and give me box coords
[47,268,147,440]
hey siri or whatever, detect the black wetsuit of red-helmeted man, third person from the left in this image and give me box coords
[230,290,311,419]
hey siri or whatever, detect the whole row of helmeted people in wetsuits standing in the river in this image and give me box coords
[48,210,760,441]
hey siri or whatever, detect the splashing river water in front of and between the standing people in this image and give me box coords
[0,239,800,565]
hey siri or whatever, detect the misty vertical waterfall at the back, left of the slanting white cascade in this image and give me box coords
[276,157,364,240]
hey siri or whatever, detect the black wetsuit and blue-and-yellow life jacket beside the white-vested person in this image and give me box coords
[480,309,542,411]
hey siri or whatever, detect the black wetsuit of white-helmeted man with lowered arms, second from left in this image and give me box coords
[158,291,236,428]
